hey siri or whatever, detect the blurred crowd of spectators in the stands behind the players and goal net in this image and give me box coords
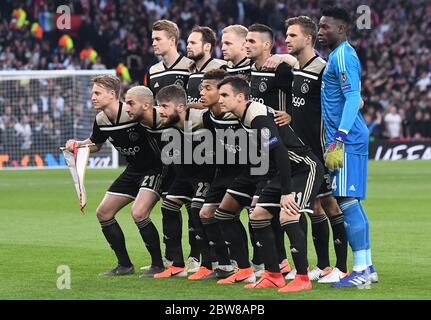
[0,0,431,149]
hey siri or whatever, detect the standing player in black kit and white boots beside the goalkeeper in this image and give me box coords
[286,16,348,283]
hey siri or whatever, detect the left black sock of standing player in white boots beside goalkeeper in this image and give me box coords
[310,214,330,270]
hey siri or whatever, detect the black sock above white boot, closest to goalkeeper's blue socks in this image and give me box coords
[329,214,347,272]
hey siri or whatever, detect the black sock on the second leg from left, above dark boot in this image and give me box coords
[136,217,163,267]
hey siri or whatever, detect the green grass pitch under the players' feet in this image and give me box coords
[0,161,431,300]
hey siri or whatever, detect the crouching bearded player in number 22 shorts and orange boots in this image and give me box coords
[154,85,215,280]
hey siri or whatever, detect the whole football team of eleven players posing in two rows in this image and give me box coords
[65,11,379,293]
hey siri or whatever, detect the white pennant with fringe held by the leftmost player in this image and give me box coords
[60,145,90,213]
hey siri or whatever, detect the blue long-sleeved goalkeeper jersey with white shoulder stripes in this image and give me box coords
[321,41,368,155]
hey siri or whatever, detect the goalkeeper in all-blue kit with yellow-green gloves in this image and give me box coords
[318,7,377,287]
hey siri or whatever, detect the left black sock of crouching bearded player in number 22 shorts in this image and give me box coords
[162,199,184,267]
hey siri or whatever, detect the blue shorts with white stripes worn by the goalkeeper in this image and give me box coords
[331,152,368,200]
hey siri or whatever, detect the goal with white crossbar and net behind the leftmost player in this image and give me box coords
[0,70,118,170]
